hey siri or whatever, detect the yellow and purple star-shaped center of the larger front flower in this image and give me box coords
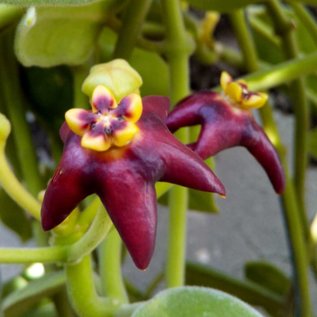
[65,85,143,152]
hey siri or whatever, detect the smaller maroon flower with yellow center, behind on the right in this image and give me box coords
[166,72,284,193]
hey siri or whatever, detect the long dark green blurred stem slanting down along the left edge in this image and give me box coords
[0,32,42,195]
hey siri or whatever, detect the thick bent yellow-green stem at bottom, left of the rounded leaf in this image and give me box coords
[65,255,117,317]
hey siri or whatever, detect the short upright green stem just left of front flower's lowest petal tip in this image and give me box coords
[98,228,128,303]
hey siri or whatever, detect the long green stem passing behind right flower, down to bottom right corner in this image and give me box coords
[231,11,311,316]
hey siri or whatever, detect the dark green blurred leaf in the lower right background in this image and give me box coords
[244,261,291,296]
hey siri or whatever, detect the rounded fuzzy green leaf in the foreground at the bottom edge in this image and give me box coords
[132,286,261,317]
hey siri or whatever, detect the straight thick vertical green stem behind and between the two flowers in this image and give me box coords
[161,0,192,287]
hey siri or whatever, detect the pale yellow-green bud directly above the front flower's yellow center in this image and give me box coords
[82,59,142,101]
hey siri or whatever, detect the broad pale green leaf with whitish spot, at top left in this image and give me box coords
[15,1,107,67]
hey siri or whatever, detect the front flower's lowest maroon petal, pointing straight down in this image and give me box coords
[97,160,157,269]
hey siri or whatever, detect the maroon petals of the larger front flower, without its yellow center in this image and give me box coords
[42,96,225,269]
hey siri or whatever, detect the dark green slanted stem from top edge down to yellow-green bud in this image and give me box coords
[113,0,152,59]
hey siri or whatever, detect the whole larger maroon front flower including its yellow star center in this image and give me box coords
[42,85,225,269]
